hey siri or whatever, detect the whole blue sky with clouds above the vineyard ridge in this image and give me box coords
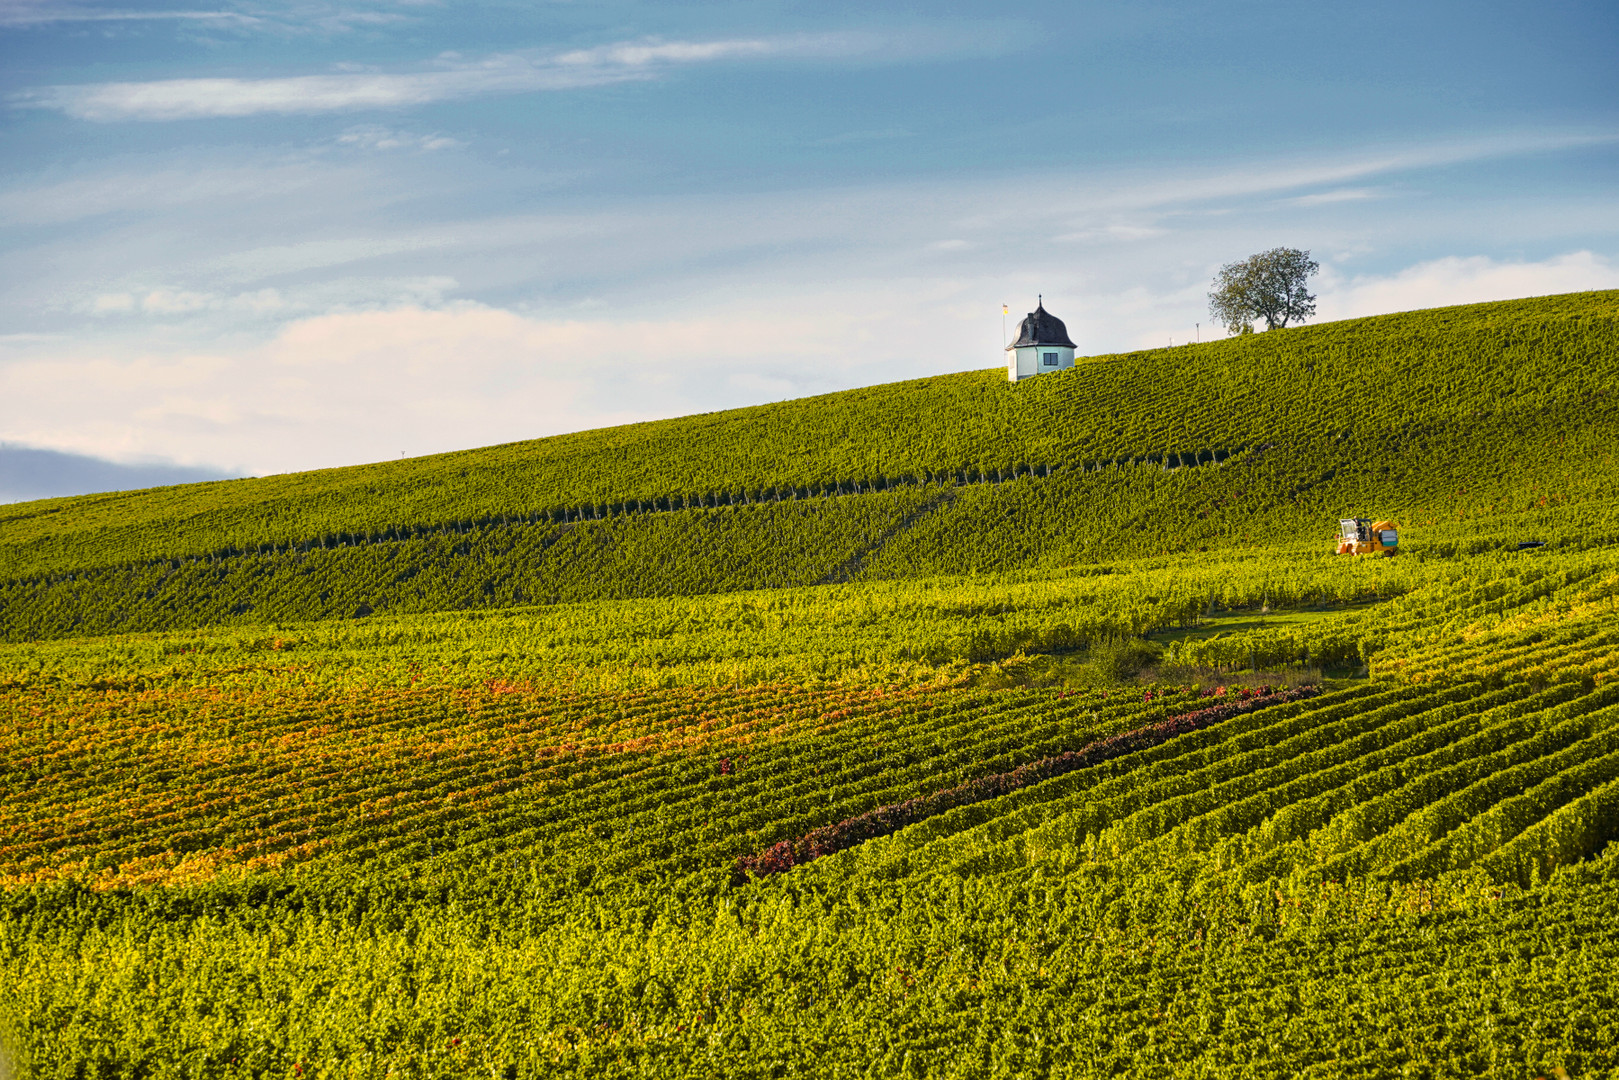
[0,0,1619,500]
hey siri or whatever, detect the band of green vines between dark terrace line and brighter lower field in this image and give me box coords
[9,417,1619,641]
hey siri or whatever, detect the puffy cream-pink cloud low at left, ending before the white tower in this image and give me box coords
[0,304,900,473]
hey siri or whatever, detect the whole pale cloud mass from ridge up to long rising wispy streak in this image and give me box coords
[0,128,1619,473]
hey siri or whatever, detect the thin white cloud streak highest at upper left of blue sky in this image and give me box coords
[11,34,876,121]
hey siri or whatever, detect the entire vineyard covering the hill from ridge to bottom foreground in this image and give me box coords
[0,293,1619,1078]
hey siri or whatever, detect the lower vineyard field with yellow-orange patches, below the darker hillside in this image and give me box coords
[0,546,1619,1077]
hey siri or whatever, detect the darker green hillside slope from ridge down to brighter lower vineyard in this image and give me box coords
[0,293,1619,641]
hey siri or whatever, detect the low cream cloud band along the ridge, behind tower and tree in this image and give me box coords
[0,251,1619,473]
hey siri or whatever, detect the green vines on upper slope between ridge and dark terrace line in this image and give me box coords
[0,291,1619,592]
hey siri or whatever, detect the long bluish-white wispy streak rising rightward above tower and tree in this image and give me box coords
[154,134,1588,297]
